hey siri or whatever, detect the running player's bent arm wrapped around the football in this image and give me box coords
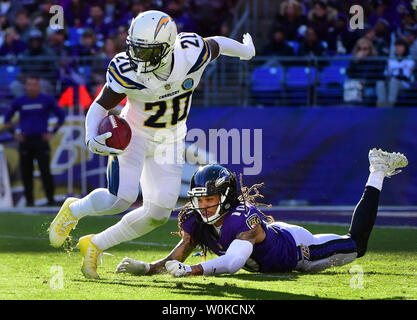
[85,84,126,156]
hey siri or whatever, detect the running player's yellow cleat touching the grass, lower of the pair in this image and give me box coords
[77,234,103,279]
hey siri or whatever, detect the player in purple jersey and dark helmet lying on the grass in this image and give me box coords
[116,149,408,277]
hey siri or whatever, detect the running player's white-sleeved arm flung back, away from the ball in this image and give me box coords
[204,33,256,61]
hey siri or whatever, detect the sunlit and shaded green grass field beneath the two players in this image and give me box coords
[0,214,417,300]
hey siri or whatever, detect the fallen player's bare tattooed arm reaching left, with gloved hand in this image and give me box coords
[116,232,196,275]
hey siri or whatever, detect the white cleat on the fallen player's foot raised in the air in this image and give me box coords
[368,148,408,178]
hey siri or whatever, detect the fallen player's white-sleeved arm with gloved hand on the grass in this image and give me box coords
[165,225,265,277]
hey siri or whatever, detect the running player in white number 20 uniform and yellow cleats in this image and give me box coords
[48,10,255,278]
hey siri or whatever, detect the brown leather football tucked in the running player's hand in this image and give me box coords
[98,114,132,150]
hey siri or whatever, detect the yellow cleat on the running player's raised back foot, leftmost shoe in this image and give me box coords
[48,198,78,248]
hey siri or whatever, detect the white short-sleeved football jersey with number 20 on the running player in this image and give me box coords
[106,33,211,142]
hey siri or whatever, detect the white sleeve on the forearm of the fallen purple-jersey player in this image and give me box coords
[201,239,253,275]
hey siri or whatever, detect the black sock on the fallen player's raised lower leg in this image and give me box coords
[348,186,381,258]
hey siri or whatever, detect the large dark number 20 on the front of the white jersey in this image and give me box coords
[143,91,193,129]
